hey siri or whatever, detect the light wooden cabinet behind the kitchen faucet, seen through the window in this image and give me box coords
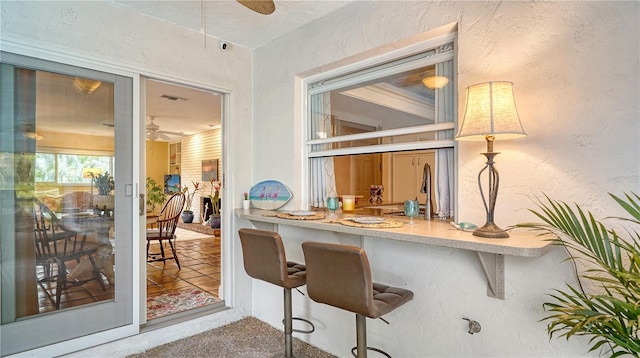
[385,151,436,206]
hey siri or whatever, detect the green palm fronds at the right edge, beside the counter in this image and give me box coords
[517,194,640,357]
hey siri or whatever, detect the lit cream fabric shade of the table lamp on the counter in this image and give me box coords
[456,82,527,140]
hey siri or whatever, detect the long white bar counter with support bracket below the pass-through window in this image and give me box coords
[235,209,553,299]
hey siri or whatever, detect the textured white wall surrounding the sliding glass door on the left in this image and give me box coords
[0,1,252,357]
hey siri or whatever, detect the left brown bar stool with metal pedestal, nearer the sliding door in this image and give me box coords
[238,229,315,357]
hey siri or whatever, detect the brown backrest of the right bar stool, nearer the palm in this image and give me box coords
[302,241,374,317]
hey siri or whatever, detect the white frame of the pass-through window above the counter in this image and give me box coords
[295,23,458,208]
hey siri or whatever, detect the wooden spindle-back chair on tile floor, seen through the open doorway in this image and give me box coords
[147,192,185,269]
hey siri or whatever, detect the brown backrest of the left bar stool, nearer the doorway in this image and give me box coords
[238,228,299,287]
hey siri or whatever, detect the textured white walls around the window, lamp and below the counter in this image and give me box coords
[0,1,640,357]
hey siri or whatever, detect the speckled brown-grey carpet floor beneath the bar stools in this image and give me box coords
[129,317,335,358]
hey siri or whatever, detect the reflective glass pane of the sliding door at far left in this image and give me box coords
[0,68,116,324]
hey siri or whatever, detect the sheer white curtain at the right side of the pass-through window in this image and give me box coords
[435,60,455,216]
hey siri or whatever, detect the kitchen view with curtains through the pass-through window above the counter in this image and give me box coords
[308,53,455,220]
